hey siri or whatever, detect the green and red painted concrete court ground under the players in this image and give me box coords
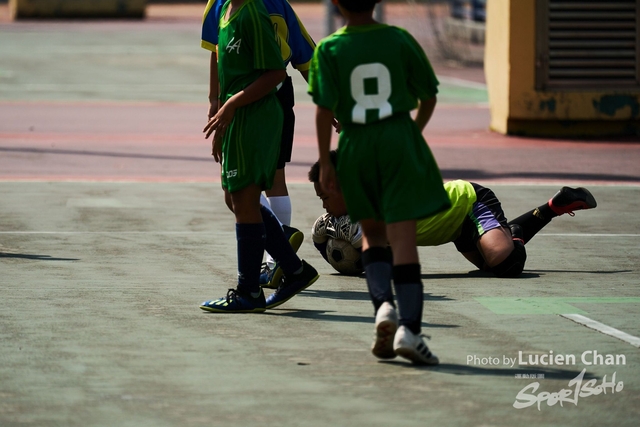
[0,4,640,427]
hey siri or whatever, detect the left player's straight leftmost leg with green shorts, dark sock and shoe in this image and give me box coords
[200,96,282,312]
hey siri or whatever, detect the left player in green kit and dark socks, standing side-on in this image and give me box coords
[200,0,318,313]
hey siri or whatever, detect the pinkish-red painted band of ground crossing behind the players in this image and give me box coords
[0,4,640,185]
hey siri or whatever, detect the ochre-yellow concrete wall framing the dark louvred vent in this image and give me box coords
[485,0,640,137]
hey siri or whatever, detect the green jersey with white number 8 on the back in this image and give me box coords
[309,24,438,126]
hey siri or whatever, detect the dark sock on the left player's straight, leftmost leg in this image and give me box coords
[236,222,265,294]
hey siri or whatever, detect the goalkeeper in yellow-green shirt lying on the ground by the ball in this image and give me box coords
[309,151,597,277]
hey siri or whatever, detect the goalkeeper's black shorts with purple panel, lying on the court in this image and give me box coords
[453,182,508,252]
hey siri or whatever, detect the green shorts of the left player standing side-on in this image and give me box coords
[222,94,282,193]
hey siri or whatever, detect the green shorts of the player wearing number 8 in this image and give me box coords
[337,114,451,224]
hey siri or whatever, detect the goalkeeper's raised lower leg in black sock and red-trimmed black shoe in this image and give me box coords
[509,187,598,243]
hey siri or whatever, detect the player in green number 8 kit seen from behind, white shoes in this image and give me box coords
[309,0,450,365]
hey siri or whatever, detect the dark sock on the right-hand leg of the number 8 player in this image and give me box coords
[393,264,424,335]
